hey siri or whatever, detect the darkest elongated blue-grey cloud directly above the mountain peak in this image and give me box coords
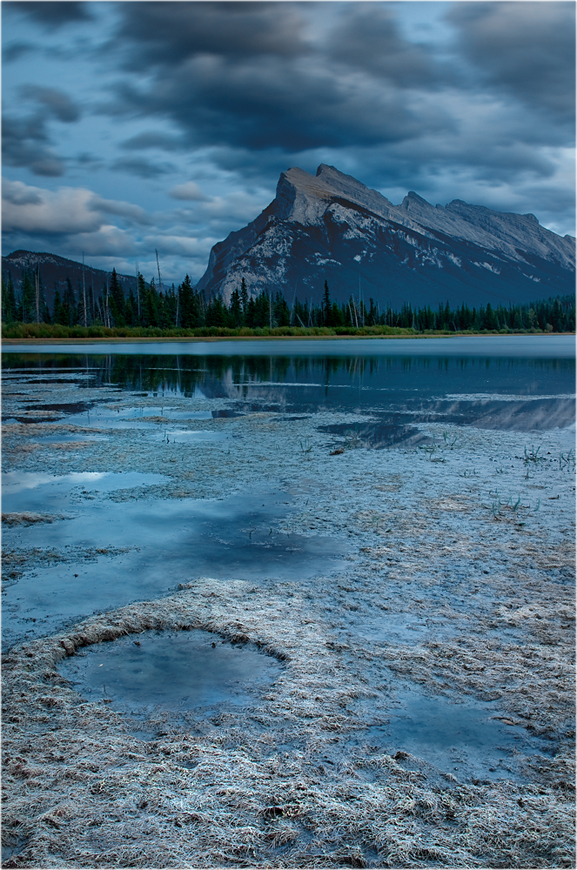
[117,57,428,151]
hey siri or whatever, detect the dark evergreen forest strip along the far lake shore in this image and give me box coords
[2,270,575,338]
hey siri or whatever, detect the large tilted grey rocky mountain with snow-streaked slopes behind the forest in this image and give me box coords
[197,164,575,308]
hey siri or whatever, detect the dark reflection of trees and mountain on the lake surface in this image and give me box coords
[3,339,575,432]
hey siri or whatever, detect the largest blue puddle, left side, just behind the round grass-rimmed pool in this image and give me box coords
[2,490,348,646]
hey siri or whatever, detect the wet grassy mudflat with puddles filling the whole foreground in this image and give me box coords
[2,344,575,867]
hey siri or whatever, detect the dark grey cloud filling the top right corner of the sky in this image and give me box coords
[448,2,575,122]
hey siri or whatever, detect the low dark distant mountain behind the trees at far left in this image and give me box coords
[2,251,136,305]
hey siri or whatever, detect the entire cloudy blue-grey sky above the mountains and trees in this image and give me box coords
[2,0,575,283]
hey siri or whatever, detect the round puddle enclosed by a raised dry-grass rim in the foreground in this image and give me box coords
[58,629,283,714]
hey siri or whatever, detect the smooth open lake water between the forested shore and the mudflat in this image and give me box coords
[2,336,575,430]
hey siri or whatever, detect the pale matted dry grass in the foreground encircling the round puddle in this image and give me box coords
[3,578,573,867]
